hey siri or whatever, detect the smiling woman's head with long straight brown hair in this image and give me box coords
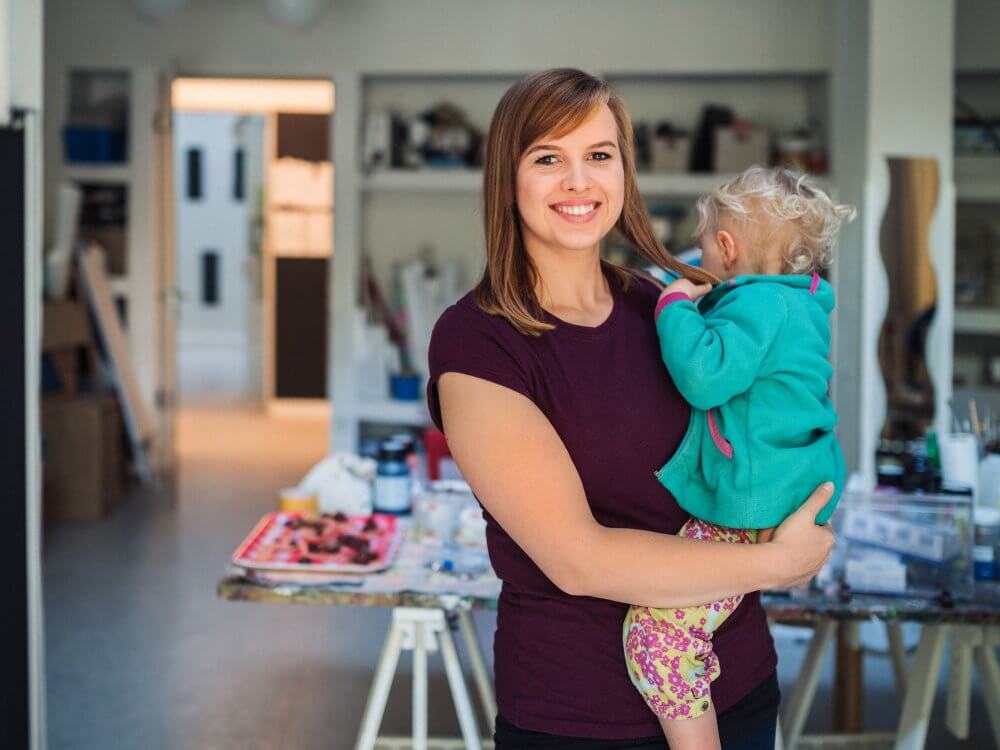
[475,68,712,335]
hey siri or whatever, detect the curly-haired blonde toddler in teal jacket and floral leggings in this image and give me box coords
[623,167,854,750]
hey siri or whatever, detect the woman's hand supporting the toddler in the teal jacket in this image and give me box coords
[767,482,834,588]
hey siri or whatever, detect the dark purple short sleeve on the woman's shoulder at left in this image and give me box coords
[427,298,534,431]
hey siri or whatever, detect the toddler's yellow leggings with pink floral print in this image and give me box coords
[622,518,757,719]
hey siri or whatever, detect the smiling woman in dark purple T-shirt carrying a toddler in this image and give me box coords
[428,70,833,750]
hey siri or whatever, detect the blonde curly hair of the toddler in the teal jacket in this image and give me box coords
[696,167,857,274]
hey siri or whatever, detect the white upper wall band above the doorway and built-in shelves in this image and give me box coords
[47,0,831,76]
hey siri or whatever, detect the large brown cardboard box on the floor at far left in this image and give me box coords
[42,395,124,523]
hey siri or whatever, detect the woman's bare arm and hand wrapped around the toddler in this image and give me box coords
[437,372,833,607]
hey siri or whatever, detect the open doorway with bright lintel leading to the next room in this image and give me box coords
[171,78,334,420]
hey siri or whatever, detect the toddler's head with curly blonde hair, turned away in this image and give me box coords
[697,167,855,279]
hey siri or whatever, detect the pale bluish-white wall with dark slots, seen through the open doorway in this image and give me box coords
[174,112,265,401]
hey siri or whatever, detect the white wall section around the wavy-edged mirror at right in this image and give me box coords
[833,0,955,479]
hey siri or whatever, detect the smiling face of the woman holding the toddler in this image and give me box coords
[517,105,625,258]
